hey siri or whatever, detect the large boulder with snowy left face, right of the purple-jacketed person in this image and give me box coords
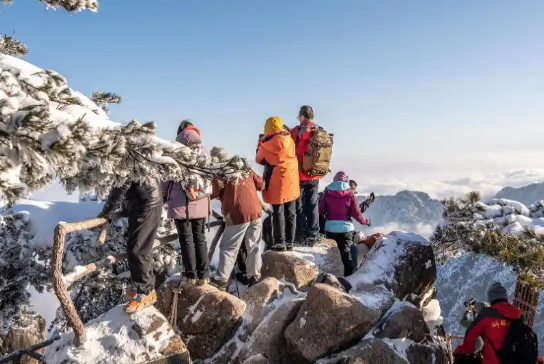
[347,231,436,300]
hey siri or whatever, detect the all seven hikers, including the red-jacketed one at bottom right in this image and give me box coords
[99,105,539,364]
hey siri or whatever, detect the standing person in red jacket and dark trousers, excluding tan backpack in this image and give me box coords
[291,105,323,246]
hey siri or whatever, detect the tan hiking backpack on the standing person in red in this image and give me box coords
[300,127,334,177]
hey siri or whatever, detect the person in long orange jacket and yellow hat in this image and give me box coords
[256,116,300,251]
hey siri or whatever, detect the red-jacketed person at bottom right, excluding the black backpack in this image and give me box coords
[453,282,522,364]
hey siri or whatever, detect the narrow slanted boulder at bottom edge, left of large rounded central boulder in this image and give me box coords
[239,298,304,364]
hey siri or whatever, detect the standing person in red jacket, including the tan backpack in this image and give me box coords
[291,105,332,246]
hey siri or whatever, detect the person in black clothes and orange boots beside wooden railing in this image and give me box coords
[98,180,163,313]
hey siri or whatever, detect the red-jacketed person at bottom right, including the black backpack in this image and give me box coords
[453,282,538,364]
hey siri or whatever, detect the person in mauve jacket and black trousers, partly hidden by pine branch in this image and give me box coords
[162,121,212,285]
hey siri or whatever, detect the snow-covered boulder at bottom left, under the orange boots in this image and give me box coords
[44,305,191,364]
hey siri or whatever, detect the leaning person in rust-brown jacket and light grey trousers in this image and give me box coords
[211,171,264,290]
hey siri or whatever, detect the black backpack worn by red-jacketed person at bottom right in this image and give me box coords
[489,317,538,364]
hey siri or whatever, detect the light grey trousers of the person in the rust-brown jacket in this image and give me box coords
[217,219,262,281]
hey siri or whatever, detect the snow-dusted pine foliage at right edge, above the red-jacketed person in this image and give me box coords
[431,192,544,288]
